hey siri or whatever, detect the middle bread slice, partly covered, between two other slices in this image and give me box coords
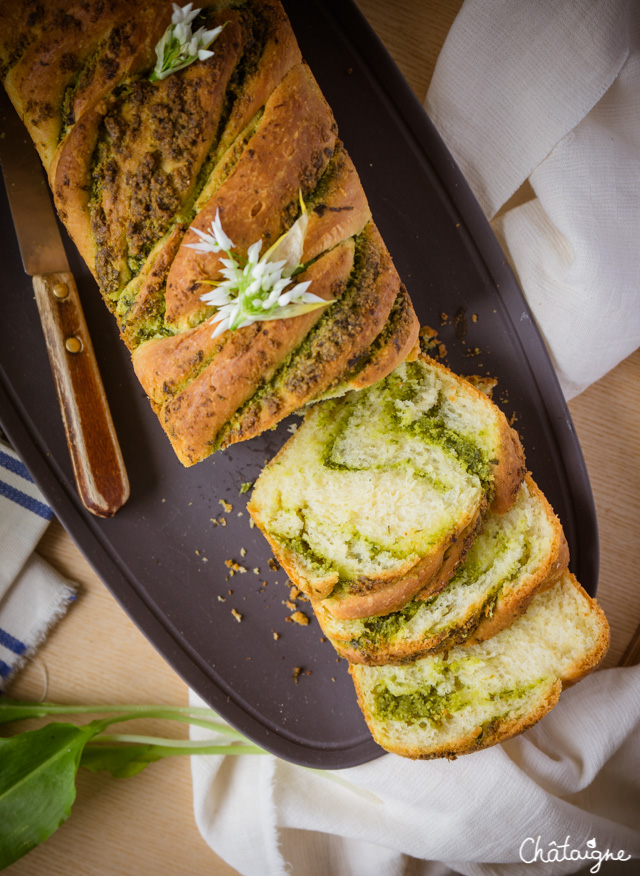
[314,475,569,666]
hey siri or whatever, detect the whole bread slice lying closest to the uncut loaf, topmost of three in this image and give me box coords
[248,355,525,617]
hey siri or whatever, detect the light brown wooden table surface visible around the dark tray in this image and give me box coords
[6,0,640,876]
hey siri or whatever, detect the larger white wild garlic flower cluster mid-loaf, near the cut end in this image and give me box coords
[185,198,333,338]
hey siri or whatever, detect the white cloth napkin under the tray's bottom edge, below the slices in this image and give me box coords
[191,666,640,876]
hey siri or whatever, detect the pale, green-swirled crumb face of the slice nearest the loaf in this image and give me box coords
[253,360,492,584]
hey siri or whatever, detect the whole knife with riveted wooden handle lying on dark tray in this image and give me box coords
[0,96,129,517]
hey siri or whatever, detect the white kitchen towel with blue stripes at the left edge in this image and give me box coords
[0,441,76,691]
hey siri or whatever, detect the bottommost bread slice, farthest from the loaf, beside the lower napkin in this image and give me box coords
[350,572,609,759]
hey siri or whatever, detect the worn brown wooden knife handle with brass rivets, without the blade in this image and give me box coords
[33,271,129,517]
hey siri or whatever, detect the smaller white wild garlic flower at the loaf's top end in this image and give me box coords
[149,3,224,82]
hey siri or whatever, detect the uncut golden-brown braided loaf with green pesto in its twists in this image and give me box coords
[0,0,418,465]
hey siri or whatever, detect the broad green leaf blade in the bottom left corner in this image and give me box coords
[0,722,102,869]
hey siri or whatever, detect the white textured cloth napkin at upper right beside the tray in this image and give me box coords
[425,0,640,398]
